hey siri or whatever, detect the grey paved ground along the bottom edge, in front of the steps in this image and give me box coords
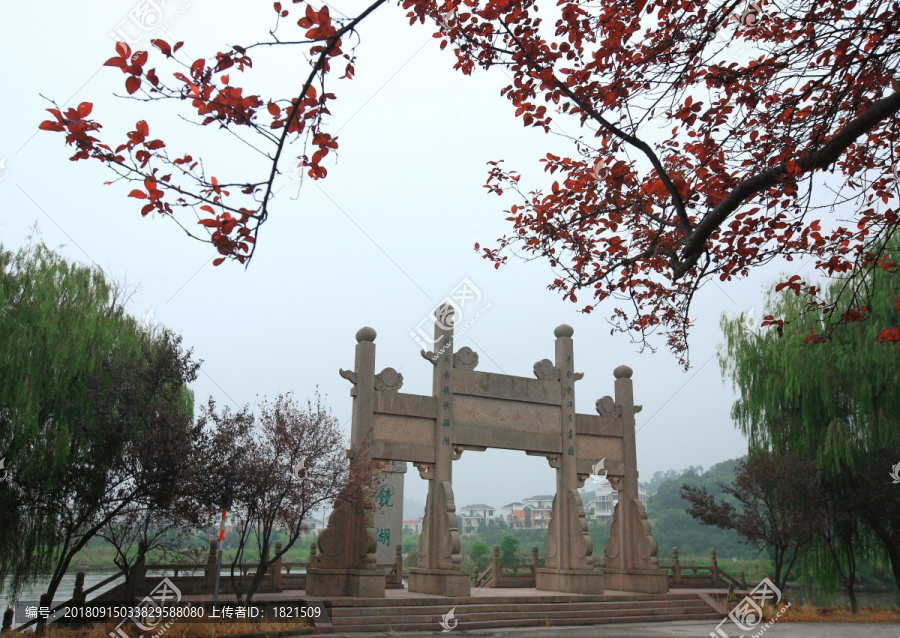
[318,620,900,638]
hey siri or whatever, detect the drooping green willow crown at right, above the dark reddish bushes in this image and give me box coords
[719,246,900,473]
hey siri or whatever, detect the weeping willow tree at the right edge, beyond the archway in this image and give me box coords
[719,240,900,600]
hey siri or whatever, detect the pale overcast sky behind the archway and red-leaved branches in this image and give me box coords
[0,0,801,520]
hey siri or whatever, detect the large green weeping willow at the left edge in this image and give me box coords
[0,244,199,600]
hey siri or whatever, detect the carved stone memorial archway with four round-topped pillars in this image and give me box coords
[307,306,668,597]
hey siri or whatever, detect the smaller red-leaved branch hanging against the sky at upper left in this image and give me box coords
[40,0,385,265]
